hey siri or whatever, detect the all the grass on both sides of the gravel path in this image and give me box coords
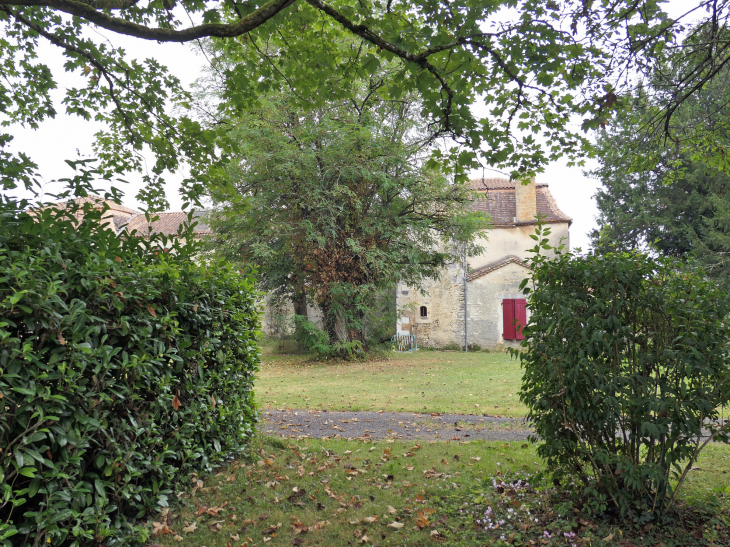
[148,346,730,547]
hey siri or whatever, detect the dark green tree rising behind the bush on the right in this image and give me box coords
[591,57,730,282]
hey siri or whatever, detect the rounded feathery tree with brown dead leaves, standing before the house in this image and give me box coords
[208,89,486,348]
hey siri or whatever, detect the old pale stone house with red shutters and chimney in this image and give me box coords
[396,178,572,349]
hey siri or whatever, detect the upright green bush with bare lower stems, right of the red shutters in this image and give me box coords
[520,225,730,519]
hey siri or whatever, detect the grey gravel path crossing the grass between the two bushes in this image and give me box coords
[262,409,533,441]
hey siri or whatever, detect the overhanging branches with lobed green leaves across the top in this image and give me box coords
[0,0,726,206]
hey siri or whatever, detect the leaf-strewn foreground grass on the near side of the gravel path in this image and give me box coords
[146,436,730,547]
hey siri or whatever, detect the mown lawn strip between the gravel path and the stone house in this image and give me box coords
[255,344,526,417]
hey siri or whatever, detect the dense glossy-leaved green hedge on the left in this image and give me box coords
[0,202,258,547]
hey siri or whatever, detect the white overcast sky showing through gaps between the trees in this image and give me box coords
[4,0,696,249]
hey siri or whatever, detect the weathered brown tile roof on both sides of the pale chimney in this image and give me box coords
[469,178,573,227]
